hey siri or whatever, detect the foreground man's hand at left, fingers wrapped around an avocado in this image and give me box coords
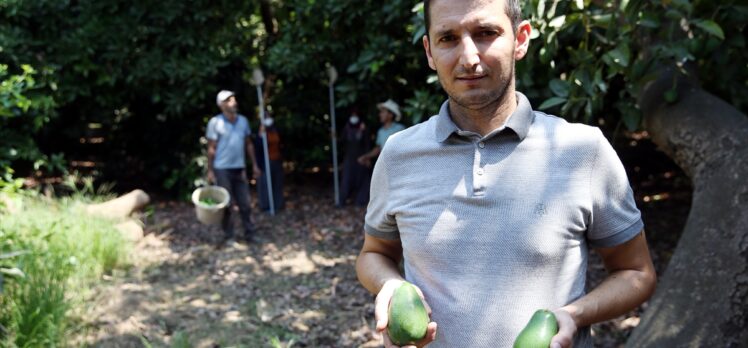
[374,279,436,348]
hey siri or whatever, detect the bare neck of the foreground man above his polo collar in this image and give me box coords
[449,89,517,136]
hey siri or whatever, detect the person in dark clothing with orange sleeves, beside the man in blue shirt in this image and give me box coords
[254,114,285,211]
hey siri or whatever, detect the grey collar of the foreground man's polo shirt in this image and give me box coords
[436,92,535,142]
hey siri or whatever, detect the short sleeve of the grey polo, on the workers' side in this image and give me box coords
[364,147,400,240]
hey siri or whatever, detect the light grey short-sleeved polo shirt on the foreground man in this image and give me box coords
[365,93,643,348]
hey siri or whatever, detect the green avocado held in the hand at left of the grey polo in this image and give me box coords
[387,282,429,346]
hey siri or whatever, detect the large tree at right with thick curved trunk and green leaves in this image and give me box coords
[518,0,748,347]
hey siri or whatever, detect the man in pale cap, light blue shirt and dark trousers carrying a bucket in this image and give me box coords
[205,90,262,243]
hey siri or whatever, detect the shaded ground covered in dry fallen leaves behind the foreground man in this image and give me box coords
[75,139,691,347]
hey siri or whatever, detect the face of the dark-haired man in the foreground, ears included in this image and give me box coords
[423,0,530,109]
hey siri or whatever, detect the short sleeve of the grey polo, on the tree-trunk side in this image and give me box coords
[587,130,644,248]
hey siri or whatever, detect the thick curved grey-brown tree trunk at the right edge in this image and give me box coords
[626,73,748,348]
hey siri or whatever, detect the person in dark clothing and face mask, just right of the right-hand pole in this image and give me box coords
[340,111,371,206]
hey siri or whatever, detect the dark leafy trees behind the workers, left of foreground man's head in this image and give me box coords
[0,0,440,196]
